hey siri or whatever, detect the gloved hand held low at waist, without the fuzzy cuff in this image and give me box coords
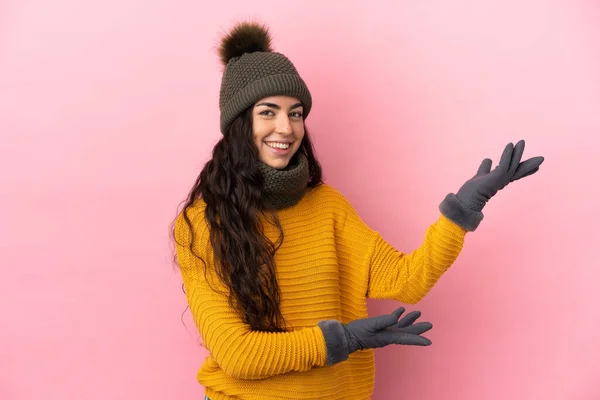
[342,307,433,353]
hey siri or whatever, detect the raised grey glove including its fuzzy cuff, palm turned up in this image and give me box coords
[440,140,544,231]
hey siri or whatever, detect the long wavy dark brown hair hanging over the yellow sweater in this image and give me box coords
[173,107,322,332]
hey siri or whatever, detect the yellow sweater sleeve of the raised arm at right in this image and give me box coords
[337,191,466,304]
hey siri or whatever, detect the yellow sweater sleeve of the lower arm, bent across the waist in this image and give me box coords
[175,208,327,379]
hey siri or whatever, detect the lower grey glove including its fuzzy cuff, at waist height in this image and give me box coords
[318,307,433,365]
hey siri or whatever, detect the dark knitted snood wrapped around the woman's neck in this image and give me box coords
[258,151,309,209]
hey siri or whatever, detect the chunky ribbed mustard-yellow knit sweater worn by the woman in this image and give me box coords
[175,184,466,400]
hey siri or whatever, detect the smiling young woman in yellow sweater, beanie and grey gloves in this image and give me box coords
[174,23,543,400]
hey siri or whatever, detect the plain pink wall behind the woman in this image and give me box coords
[0,0,600,400]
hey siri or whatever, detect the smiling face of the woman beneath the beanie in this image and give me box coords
[252,96,304,169]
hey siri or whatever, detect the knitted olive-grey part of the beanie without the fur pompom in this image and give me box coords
[219,52,312,133]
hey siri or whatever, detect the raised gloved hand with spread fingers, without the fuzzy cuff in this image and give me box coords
[456,140,544,212]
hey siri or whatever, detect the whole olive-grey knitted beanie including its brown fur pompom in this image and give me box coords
[219,22,312,134]
